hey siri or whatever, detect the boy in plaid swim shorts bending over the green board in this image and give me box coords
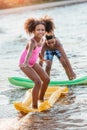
[39,32,76,80]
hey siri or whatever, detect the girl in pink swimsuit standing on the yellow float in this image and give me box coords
[19,18,53,109]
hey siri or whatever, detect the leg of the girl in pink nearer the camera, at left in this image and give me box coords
[20,67,42,108]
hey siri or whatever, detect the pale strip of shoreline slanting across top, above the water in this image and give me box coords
[0,0,87,15]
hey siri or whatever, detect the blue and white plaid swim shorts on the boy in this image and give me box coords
[45,50,61,61]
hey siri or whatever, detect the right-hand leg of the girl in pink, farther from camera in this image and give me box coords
[33,64,50,100]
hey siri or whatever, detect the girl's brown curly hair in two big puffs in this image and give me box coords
[24,16,55,34]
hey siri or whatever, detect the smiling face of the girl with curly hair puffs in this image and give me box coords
[34,24,45,39]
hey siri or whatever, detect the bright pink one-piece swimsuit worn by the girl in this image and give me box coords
[19,46,42,67]
